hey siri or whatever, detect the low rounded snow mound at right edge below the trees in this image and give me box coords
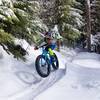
[73,52,100,68]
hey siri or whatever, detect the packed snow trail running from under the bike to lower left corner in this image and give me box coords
[0,69,65,100]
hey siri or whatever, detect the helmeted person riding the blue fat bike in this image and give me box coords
[34,30,62,61]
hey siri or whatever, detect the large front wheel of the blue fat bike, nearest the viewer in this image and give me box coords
[35,55,51,78]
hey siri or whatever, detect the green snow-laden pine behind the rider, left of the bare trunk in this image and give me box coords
[56,0,83,45]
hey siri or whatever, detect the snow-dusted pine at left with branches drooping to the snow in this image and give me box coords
[0,0,44,59]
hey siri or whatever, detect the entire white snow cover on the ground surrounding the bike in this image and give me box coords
[0,41,100,100]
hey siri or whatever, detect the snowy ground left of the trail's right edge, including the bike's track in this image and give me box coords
[0,41,71,100]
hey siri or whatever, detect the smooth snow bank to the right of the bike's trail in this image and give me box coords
[34,52,100,100]
